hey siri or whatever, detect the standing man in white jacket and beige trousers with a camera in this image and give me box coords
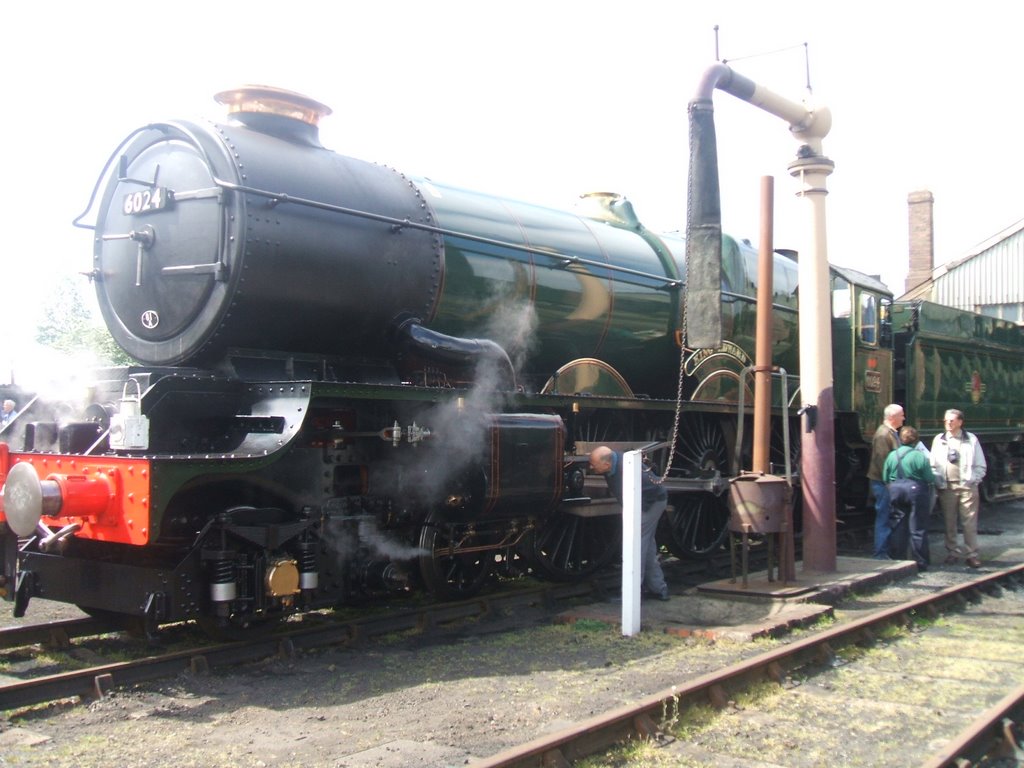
[931,409,988,568]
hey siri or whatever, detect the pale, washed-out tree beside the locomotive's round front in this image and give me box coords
[36,276,133,366]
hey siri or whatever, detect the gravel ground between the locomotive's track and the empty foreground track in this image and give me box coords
[0,502,1024,768]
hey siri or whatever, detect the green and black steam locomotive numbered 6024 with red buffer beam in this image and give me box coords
[0,86,1024,634]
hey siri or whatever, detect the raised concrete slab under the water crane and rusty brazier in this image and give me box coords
[697,557,918,604]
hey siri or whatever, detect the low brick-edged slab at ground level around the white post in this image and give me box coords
[555,592,833,642]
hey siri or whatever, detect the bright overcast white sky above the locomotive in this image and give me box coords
[0,0,1024,378]
